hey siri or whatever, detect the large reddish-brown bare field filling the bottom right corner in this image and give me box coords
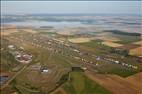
[85,71,142,94]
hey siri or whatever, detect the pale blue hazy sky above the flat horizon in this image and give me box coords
[1,1,142,14]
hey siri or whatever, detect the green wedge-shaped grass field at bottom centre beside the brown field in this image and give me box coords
[63,72,110,94]
